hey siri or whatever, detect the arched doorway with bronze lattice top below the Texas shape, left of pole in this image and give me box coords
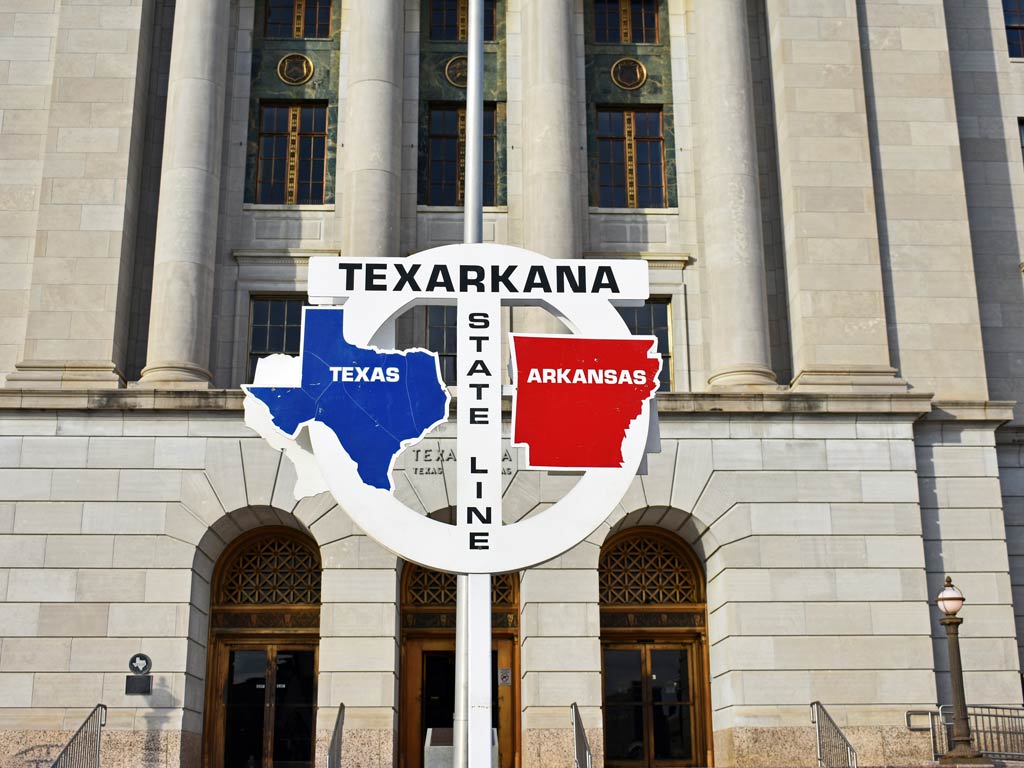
[203,527,321,768]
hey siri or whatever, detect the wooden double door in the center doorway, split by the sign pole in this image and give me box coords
[399,636,519,768]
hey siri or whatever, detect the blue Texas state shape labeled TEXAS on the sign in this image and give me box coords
[247,308,449,490]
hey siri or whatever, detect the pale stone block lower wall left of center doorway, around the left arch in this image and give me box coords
[0,398,398,768]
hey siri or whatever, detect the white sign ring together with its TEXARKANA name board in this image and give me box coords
[247,245,659,573]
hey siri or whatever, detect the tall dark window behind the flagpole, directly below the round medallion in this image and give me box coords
[426,104,498,206]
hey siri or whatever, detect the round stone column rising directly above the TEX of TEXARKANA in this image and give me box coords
[341,0,406,258]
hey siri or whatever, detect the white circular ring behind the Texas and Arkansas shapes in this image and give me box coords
[309,245,651,573]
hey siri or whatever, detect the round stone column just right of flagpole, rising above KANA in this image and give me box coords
[513,0,581,333]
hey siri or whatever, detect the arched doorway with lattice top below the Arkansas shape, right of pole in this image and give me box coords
[599,527,713,768]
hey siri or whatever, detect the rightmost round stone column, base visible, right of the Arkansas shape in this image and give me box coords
[695,0,775,386]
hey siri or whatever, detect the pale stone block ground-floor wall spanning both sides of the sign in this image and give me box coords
[0,393,1019,768]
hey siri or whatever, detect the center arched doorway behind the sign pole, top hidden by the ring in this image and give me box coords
[398,563,520,768]
